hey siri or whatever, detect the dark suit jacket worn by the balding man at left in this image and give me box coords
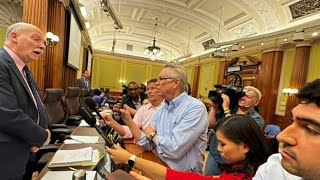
[0,48,48,179]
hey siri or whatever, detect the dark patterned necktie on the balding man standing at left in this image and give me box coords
[23,66,48,129]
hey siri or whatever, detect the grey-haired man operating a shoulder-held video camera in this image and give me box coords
[204,86,264,176]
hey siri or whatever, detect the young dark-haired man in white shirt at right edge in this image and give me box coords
[253,79,320,180]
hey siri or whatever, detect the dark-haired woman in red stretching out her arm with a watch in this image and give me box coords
[107,114,271,180]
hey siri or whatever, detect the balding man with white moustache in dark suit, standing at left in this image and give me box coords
[0,23,51,179]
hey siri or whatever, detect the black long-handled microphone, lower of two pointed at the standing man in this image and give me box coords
[79,106,115,149]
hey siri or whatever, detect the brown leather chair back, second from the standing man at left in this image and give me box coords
[65,87,81,116]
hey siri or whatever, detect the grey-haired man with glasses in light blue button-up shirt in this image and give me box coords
[121,65,208,174]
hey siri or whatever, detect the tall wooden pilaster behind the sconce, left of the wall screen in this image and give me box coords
[44,0,66,88]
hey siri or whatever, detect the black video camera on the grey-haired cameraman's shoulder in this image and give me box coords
[208,72,245,109]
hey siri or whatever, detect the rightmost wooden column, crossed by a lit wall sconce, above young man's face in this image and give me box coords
[281,44,311,129]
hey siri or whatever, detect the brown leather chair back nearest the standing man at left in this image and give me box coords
[42,88,66,127]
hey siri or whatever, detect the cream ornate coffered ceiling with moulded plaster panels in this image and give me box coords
[0,0,320,61]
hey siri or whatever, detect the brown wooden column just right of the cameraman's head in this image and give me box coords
[254,51,283,124]
